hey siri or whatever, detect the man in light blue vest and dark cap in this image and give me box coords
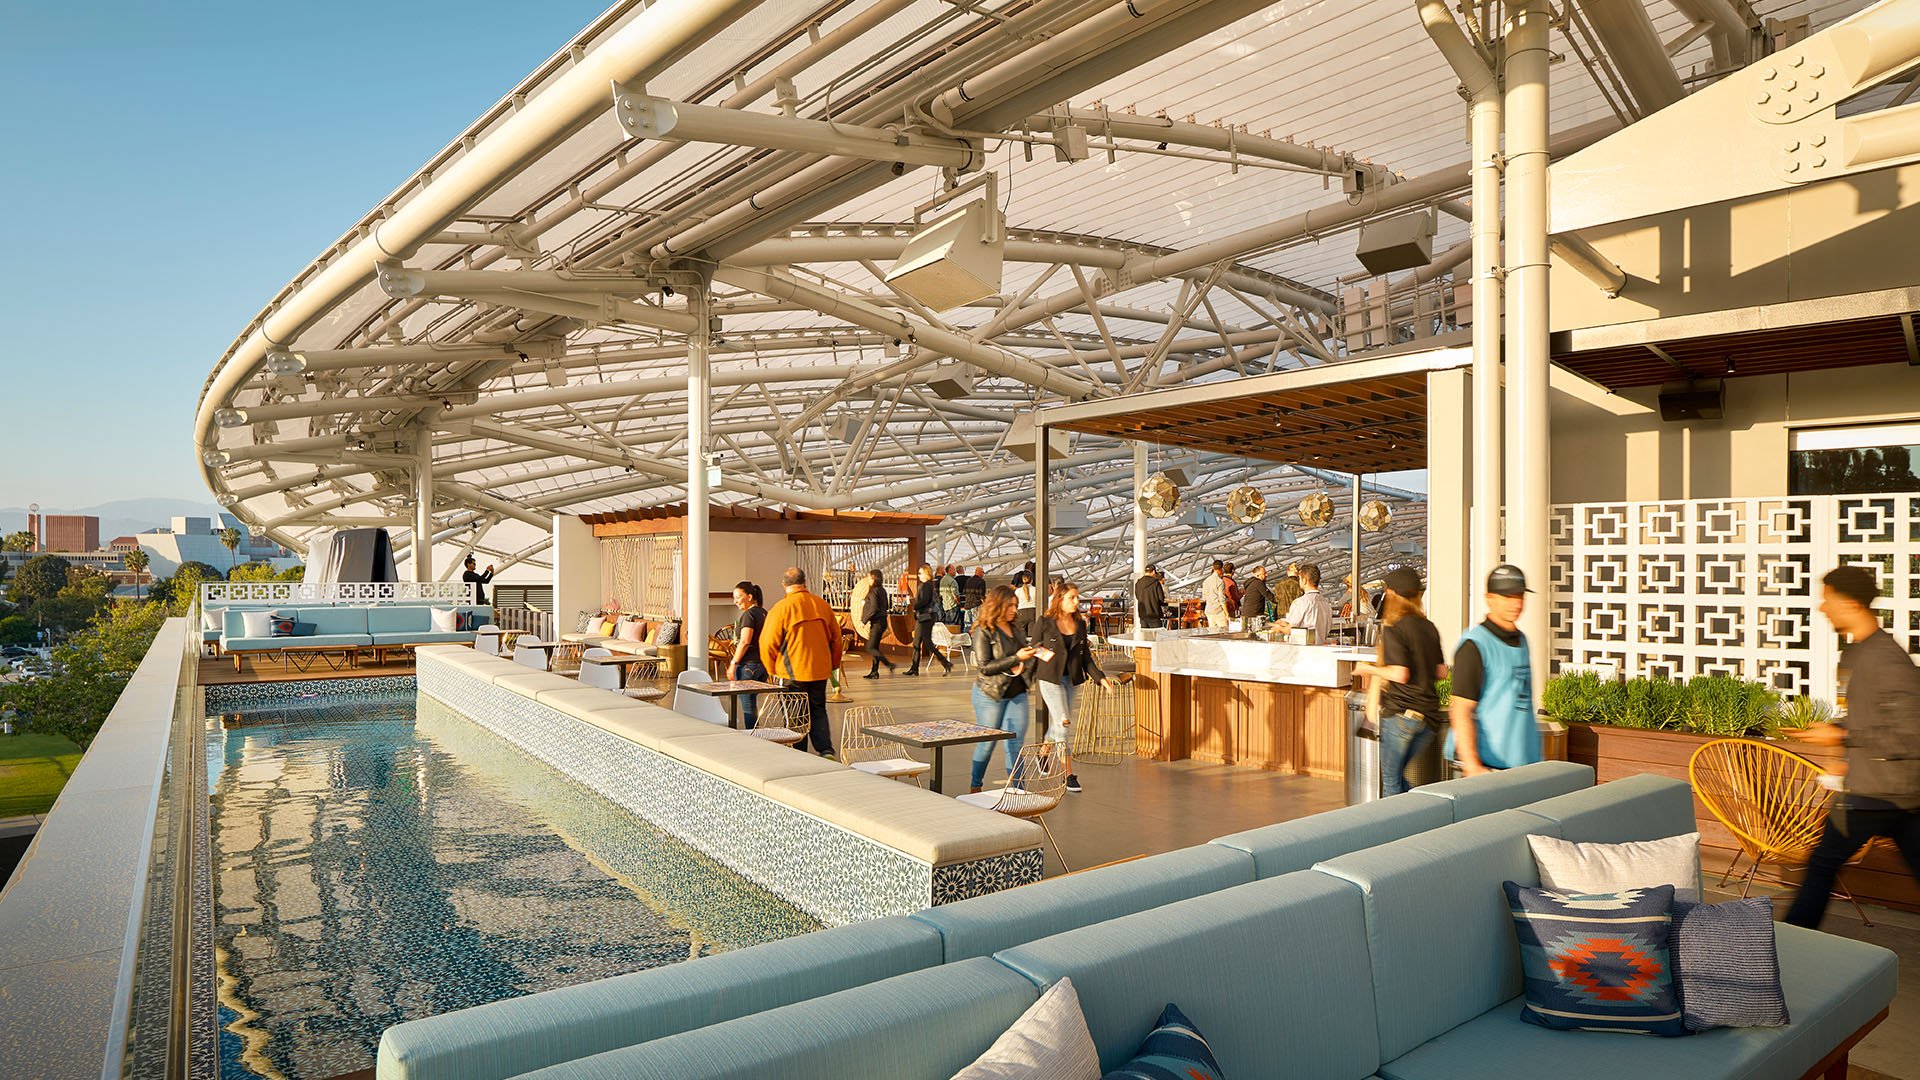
[1446,563,1540,776]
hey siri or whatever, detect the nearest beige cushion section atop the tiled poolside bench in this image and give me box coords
[764,769,1043,867]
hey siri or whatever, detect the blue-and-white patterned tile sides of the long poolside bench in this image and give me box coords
[419,653,1041,926]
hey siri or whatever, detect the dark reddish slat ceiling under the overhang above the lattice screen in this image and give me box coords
[1553,315,1910,390]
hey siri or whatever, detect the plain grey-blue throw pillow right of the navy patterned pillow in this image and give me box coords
[1672,897,1789,1032]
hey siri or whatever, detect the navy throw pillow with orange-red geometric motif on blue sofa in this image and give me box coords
[1505,882,1688,1036]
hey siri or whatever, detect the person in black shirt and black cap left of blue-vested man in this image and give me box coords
[1354,567,1448,796]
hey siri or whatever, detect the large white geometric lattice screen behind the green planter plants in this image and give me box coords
[1551,492,1920,701]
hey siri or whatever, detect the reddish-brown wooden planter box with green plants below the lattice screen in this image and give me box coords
[1567,724,1920,911]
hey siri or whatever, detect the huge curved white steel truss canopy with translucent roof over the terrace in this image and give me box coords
[194,0,1864,586]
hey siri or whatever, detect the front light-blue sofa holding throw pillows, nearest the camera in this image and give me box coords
[503,776,1897,1080]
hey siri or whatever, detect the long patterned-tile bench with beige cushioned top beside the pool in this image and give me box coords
[419,648,1043,926]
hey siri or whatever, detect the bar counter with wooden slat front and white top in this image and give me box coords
[1114,630,1373,780]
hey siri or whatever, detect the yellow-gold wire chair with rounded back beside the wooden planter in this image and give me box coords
[1686,738,1872,926]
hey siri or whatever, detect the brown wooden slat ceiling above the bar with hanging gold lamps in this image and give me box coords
[1058,373,1427,473]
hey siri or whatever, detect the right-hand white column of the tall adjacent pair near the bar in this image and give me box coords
[1505,0,1553,680]
